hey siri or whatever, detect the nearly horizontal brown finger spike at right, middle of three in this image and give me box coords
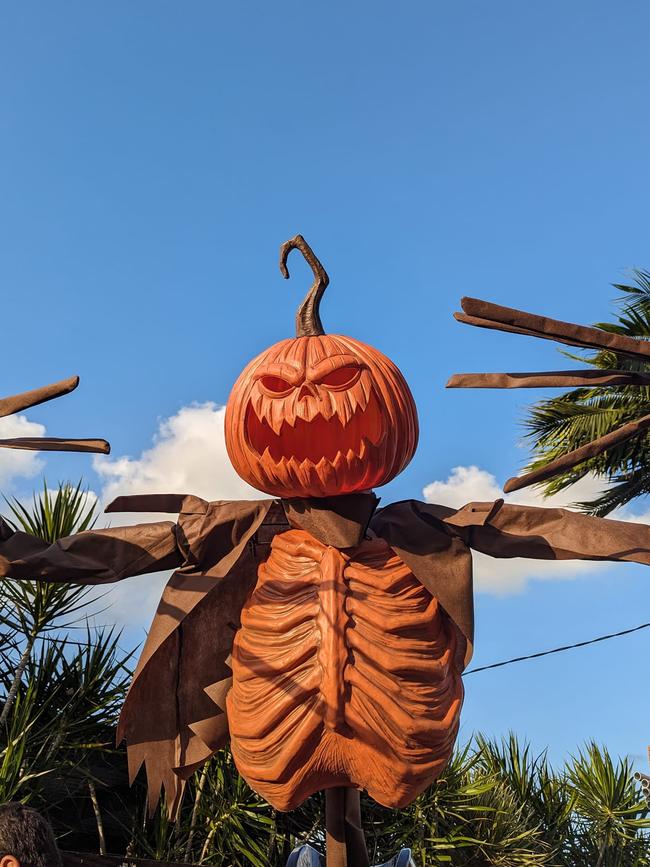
[445,367,650,388]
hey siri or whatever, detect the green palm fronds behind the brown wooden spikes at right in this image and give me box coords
[524,271,650,517]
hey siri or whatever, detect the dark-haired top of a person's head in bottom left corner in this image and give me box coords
[0,801,62,867]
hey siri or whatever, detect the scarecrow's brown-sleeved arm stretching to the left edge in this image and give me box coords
[0,518,182,584]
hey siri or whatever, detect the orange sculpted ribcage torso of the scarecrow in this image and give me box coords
[228,530,463,810]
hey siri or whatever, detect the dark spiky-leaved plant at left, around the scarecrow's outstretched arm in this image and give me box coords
[0,484,130,849]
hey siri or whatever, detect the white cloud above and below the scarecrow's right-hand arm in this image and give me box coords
[423,466,612,595]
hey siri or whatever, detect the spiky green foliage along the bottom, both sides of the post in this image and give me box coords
[119,735,650,867]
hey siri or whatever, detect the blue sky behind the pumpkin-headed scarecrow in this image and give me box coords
[0,0,650,763]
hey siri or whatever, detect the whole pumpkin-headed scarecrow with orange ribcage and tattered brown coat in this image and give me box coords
[0,236,650,867]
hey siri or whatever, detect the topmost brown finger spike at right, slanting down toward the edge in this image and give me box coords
[454,298,650,361]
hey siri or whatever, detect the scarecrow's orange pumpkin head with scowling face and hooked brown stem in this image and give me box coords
[226,235,418,497]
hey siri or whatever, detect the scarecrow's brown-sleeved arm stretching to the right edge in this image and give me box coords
[443,500,650,565]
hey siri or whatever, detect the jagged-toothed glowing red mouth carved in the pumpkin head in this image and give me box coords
[246,400,384,464]
